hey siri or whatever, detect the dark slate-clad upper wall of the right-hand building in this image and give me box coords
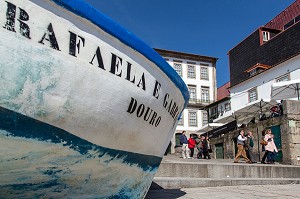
[229,22,300,86]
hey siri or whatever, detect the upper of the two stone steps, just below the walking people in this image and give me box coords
[156,161,300,180]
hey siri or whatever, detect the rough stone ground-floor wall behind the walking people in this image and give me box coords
[210,101,300,165]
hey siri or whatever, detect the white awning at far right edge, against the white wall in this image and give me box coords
[271,79,300,100]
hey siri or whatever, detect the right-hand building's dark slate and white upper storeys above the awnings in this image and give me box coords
[216,1,300,122]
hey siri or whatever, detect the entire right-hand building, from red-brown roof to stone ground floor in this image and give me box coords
[189,0,300,162]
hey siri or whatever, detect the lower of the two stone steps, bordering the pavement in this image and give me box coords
[150,177,300,190]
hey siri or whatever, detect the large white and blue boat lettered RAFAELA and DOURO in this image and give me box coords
[0,0,187,198]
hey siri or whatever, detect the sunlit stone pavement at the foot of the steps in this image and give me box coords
[146,184,300,199]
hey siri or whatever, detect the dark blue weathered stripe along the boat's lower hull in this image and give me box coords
[0,107,162,171]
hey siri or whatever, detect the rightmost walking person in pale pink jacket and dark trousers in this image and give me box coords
[261,129,278,164]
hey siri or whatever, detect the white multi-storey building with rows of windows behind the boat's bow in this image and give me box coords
[155,49,217,153]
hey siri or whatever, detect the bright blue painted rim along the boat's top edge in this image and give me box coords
[52,0,189,105]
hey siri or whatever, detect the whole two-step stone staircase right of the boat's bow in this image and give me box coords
[150,156,300,189]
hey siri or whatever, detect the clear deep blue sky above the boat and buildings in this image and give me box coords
[86,0,295,87]
